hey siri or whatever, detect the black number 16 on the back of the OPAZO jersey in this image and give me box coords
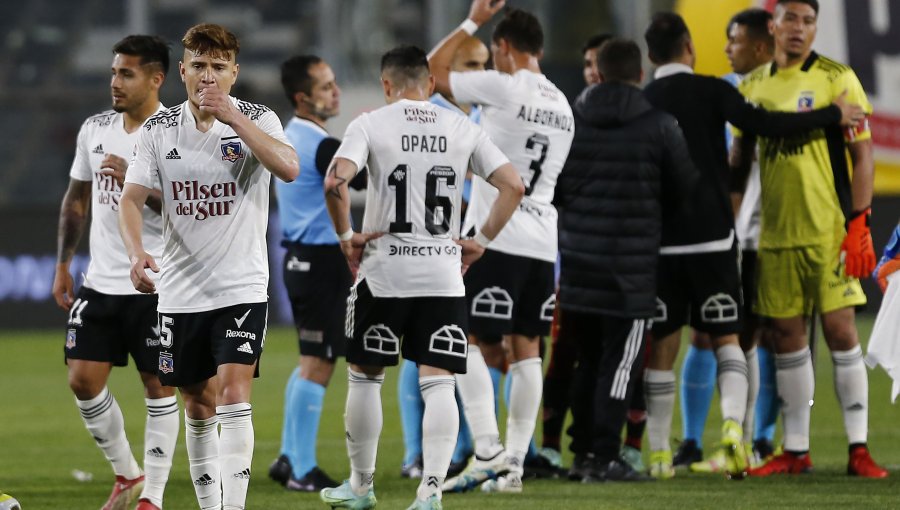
[388,164,458,236]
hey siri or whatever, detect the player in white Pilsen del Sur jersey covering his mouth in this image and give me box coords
[119,24,299,510]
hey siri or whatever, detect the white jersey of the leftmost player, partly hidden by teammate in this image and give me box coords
[69,105,164,295]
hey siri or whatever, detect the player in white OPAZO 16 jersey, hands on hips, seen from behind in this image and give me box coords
[321,46,525,510]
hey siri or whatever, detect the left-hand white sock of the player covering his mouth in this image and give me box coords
[184,411,222,510]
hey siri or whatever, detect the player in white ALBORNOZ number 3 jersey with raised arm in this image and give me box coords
[429,0,574,492]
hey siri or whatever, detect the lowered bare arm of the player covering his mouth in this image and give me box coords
[119,182,159,294]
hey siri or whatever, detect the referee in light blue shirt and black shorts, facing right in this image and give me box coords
[269,55,365,492]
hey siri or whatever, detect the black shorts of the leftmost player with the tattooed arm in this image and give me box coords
[65,286,159,374]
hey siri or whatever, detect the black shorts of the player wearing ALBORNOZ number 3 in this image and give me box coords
[465,249,556,343]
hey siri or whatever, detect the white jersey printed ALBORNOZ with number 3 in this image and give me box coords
[450,69,575,262]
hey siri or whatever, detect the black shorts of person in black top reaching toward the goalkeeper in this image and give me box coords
[653,243,744,339]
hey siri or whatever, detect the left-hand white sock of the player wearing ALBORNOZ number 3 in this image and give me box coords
[456,344,503,459]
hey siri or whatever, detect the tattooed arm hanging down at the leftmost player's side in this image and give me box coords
[53,179,91,311]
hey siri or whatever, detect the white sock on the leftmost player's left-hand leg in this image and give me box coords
[75,387,141,480]
